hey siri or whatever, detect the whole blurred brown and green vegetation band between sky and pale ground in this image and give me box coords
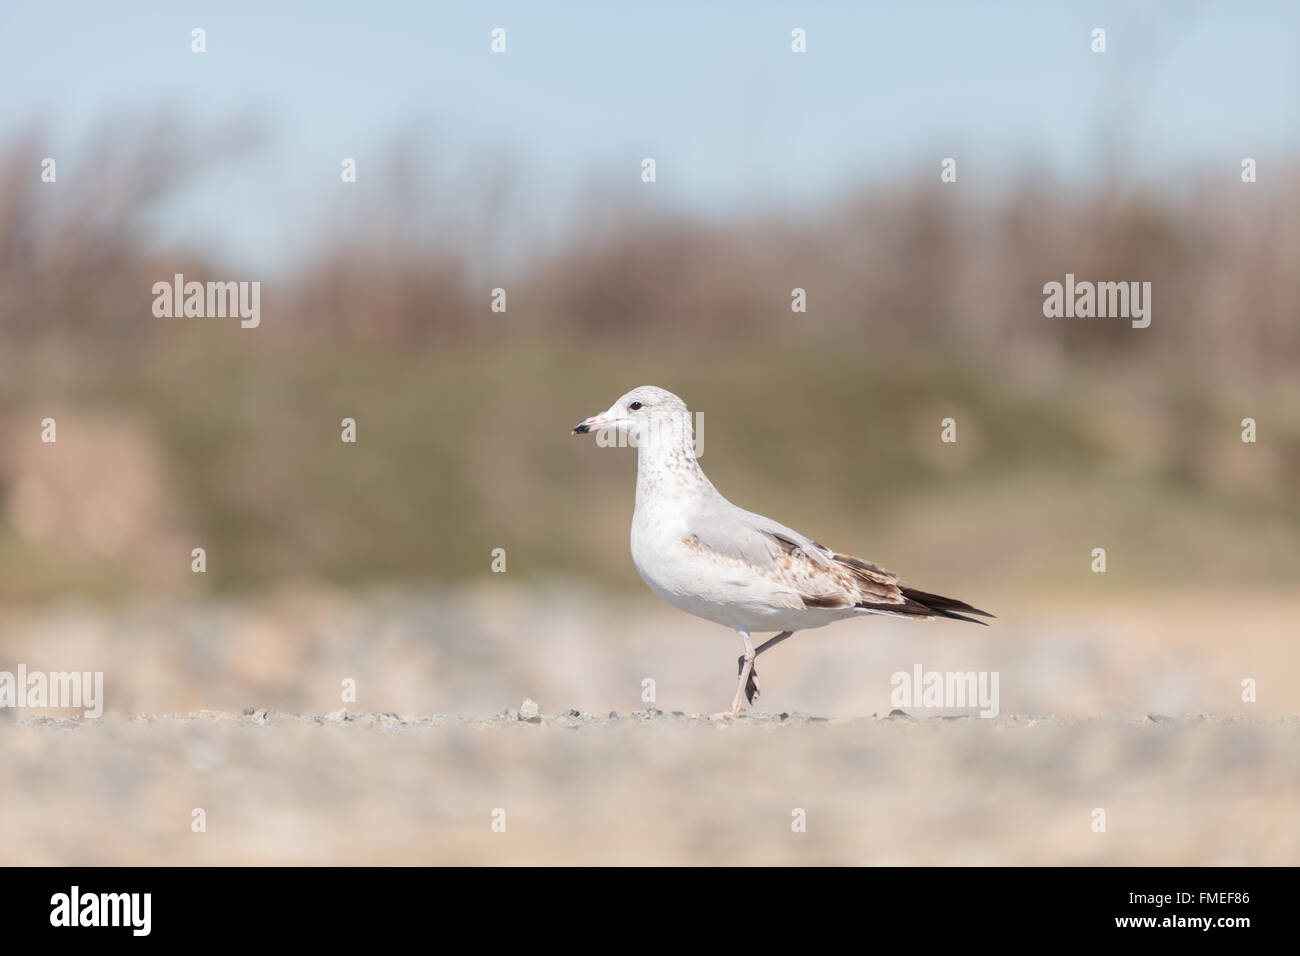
[0,134,1300,602]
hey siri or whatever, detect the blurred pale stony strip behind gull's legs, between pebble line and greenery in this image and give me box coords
[0,581,1300,724]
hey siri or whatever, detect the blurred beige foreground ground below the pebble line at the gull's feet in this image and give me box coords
[0,709,1300,865]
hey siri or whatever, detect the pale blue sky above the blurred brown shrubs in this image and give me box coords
[0,0,1300,270]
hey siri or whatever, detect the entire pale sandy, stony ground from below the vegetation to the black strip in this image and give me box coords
[0,583,1300,865]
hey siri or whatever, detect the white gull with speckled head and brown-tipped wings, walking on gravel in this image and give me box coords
[573,385,993,717]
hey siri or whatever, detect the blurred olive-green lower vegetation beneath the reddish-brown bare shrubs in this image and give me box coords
[0,333,1300,600]
